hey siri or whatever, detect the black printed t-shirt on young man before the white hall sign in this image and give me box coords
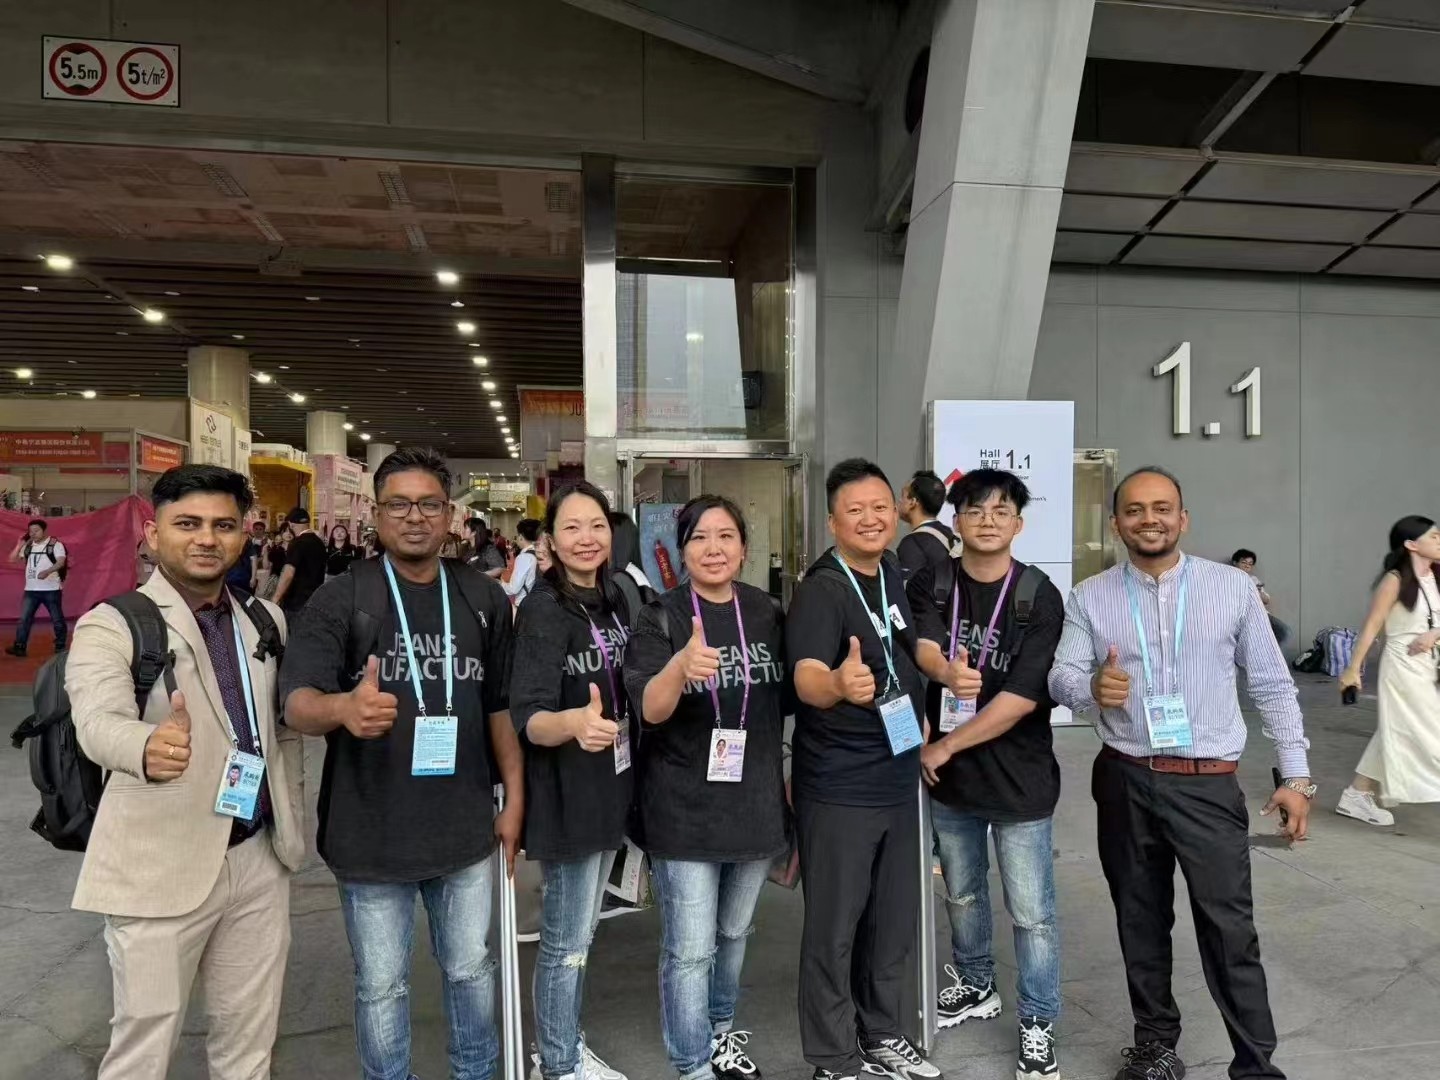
[914,559,1066,822]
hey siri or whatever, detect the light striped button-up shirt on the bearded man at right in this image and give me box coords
[1050,556,1310,778]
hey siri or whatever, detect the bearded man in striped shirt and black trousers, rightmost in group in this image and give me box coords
[1050,467,1315,1080]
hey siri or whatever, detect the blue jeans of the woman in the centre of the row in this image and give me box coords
[649,858,770,1080]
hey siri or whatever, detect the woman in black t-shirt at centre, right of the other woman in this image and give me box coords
[625,495,786,1080]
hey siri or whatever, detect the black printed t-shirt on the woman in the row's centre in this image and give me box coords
[625,582,786,863]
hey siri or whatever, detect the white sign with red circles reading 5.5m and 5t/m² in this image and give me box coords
[40,37,180,108]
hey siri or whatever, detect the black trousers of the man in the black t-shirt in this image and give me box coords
[795,799,920,1073]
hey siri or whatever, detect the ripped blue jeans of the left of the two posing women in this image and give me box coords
[531,851,615,1080]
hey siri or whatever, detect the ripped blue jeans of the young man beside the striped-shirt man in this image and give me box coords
[930,799,1060,1020]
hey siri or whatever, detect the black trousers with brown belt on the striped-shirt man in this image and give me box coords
[1090,753,1284,1080]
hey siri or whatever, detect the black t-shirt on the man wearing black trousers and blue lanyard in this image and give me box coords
[785,552,942,806]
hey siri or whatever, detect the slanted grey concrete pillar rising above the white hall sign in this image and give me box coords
[880,0,1094,484]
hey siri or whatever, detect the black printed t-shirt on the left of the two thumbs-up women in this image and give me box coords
[510,579,638,861]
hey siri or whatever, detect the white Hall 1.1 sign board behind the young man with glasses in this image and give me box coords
[929,402,1076,724]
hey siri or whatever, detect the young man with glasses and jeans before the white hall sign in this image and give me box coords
[907,469,1064,1080]
